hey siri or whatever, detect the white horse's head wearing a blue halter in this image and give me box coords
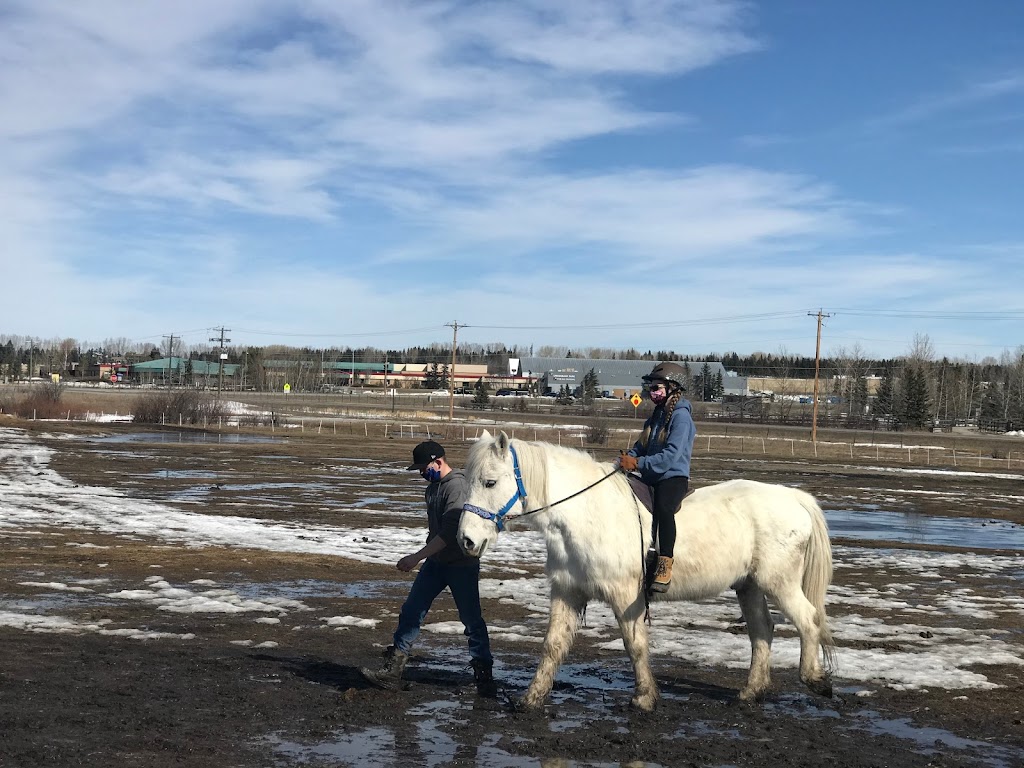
[458,431,526,557]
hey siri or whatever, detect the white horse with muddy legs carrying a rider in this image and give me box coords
[458,432,835,712]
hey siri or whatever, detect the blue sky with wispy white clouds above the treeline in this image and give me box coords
[0,0,1024,359]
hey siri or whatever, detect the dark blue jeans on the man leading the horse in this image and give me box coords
[394,558,493,663]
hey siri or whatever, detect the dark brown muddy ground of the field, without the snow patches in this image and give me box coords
[0,426,1024,768]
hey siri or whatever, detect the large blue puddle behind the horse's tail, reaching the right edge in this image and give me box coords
[825,510,1024,550]
